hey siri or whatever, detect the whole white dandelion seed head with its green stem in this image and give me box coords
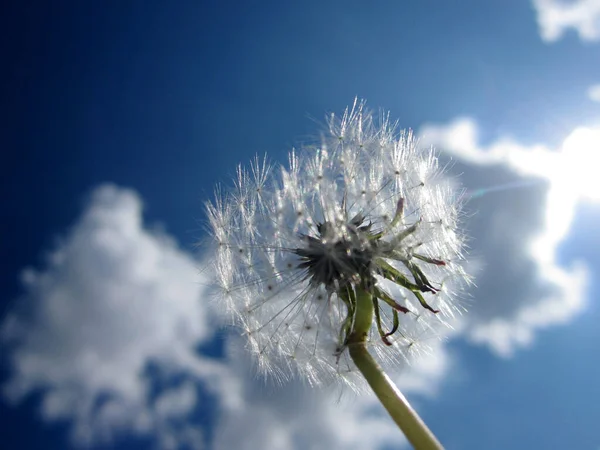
[207,100,468,448]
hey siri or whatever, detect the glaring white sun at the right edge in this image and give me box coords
[559,127,600,202]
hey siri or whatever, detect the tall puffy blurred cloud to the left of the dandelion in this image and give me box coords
[2,185,241,448]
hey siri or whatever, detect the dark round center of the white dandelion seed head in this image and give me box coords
[294,218,377,289]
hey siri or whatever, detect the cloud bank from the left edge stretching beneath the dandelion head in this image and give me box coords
[1,185,451,450]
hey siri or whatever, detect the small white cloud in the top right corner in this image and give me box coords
[533,0,600,42]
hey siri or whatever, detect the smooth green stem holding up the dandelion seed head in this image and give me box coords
[348,287,443,450]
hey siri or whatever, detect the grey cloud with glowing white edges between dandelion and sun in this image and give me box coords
[421,118,600,356]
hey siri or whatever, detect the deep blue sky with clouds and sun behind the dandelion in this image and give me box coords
[0,0,600,450]
